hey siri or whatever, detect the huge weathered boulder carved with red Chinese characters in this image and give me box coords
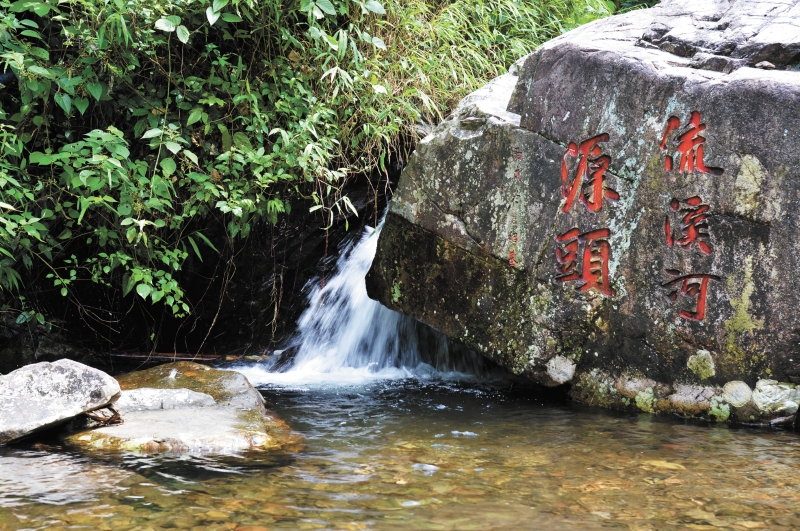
[367,0,800,424]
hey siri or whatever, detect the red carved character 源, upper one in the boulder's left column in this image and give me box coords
[561,133,619,212]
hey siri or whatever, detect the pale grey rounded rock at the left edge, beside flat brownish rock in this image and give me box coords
[0,359,120,444]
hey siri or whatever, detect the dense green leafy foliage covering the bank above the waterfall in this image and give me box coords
[0,0,605,320]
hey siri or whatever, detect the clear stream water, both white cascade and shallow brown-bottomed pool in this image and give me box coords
[0,225,800,531]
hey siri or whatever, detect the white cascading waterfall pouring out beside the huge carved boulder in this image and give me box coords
[236,216,483,385]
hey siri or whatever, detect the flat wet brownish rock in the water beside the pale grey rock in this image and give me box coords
[65,362,297,454]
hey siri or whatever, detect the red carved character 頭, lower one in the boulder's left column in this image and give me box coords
[556,229,616,297]
